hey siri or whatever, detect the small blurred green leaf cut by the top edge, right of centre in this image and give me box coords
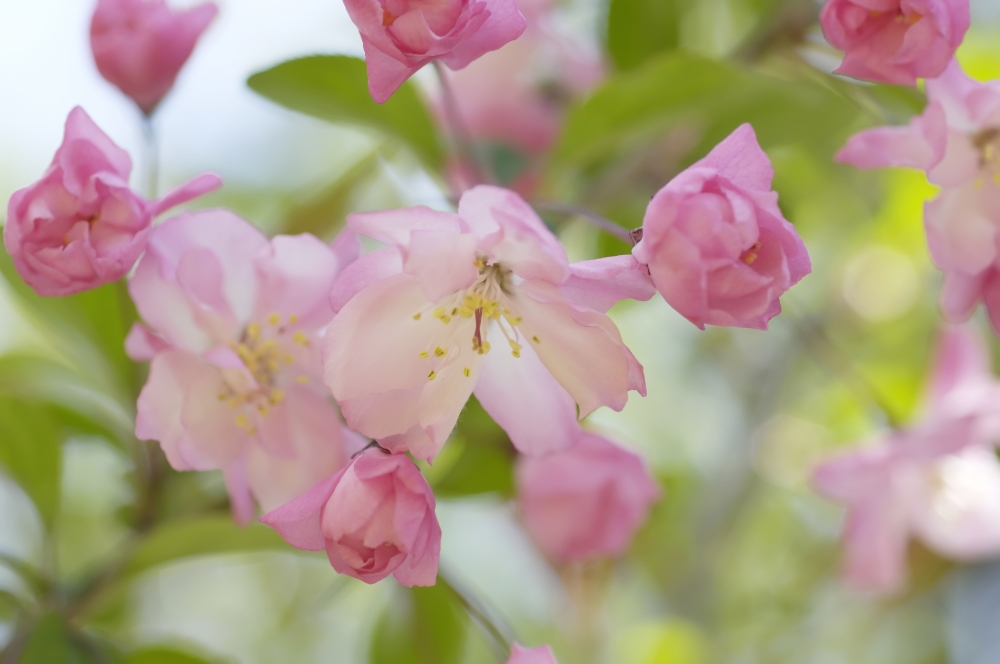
[607,0,688,70]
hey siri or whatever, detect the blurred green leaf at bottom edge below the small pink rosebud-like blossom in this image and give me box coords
[369,579,466,664]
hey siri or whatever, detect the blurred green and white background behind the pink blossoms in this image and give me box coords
[0,0,1000,664]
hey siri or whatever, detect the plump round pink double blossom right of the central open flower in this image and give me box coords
[632,124,812,330]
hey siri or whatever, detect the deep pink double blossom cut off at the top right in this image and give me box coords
[820,0,969,85]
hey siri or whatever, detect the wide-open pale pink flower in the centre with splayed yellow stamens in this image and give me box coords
[324,187,653,459]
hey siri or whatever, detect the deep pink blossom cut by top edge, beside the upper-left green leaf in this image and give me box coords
[344,0,526,104]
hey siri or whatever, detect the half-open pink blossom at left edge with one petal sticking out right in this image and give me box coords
[3,107,222,295]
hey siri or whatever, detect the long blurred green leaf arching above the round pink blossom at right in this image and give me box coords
[553,53,861,174]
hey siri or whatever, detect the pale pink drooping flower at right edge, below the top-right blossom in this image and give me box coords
[837,61,1000,330]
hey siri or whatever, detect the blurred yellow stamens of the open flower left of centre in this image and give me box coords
[219,314,310,435]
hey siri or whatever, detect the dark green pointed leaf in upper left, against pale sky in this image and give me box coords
[247,55,444,169]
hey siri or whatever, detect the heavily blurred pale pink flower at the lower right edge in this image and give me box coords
[813,328,1000,593]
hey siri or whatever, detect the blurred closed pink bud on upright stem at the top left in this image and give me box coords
[90,0,219,115]
